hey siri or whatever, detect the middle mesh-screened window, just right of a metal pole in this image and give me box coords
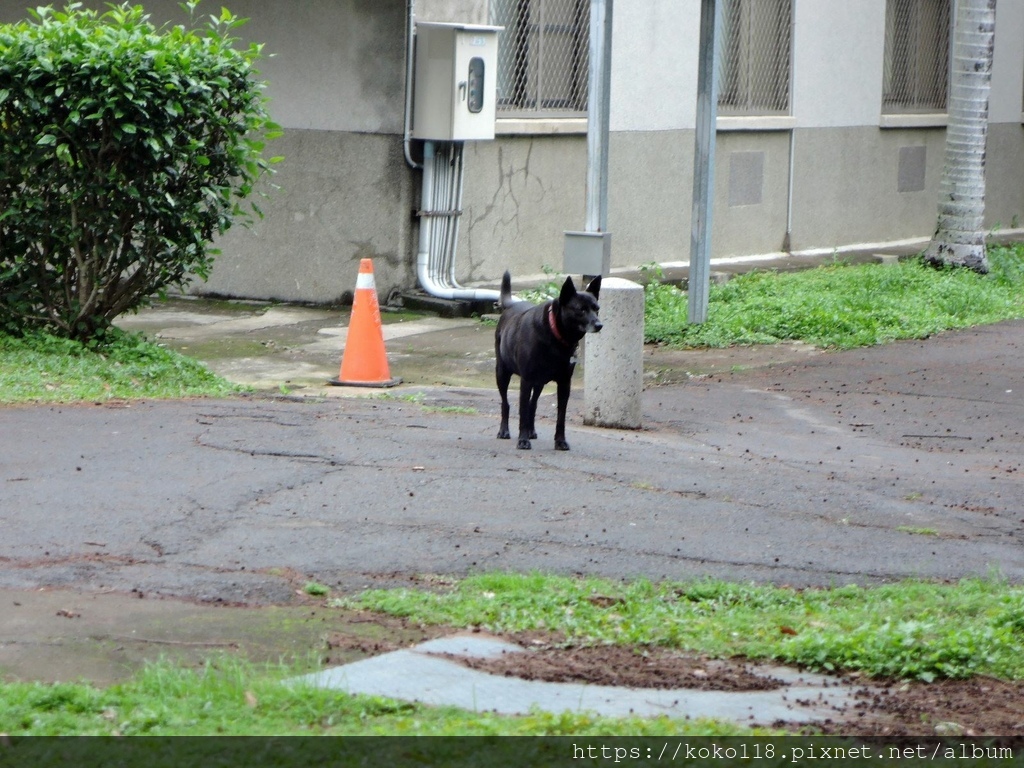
[718,0,793,115]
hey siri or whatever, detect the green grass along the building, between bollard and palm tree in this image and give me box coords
[645,244,1024,349]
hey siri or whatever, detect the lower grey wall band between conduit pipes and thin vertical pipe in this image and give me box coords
[457,130,790,283]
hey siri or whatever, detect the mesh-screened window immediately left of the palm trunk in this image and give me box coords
[882,0,951,114]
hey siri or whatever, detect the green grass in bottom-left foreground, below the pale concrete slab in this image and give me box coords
[0,656,765,736]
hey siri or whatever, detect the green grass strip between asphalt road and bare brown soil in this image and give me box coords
[341,573,1024,681]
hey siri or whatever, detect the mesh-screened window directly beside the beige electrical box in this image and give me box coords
[490,0,590,118]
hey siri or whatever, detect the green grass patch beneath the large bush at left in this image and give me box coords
[0,333,242,403]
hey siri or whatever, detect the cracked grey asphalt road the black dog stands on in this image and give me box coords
[0,323,1024,603]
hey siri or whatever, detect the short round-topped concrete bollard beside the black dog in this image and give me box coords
[584,278,644,429]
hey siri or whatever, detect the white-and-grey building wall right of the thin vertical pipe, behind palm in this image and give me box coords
[792,0,1024,250]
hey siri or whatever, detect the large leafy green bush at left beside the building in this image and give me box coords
[0,0,279,340]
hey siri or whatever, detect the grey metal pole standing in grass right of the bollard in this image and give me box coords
[688,0,722,324]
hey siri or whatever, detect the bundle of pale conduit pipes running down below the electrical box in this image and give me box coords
[416,141,501,301]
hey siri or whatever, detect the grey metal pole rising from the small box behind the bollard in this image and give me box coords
[586,0,613,232]
